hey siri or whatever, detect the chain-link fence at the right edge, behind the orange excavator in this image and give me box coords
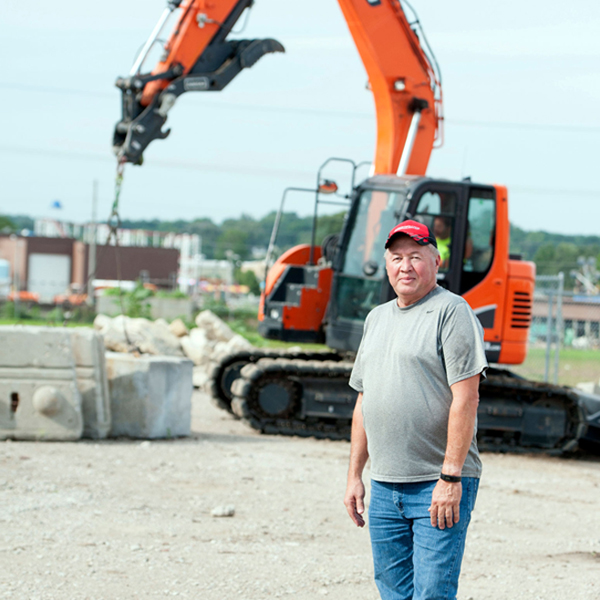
[513,273,600,393]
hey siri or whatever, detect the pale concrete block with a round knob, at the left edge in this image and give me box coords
[0,325,83,440]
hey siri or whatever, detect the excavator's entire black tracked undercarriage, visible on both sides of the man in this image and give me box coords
[211,349,600,454]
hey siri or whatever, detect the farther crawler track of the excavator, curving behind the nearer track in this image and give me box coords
[209,348,342,413]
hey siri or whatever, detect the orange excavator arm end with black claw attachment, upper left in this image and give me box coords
[113,0,284,164]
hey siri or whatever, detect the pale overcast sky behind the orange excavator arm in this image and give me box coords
[0,0,600,234]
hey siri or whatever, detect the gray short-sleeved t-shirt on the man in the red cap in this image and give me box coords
[350,287,488,483]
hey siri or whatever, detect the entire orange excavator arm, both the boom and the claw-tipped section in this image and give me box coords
[113,0,443,175]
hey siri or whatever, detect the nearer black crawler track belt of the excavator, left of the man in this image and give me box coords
[231,358,353,440]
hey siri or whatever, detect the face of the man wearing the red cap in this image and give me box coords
[385,235,440,307]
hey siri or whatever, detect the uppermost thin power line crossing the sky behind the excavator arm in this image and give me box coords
[0,82,600,134]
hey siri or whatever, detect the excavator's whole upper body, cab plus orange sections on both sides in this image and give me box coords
[259,175,535,364]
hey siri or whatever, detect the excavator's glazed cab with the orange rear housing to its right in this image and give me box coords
[325,176,535,364]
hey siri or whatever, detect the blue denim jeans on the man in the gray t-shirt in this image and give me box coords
[369,477,479,600]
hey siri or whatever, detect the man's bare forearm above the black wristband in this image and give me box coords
[442,375,479,476]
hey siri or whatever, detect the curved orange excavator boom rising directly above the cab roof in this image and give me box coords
[338,0,443,175]
